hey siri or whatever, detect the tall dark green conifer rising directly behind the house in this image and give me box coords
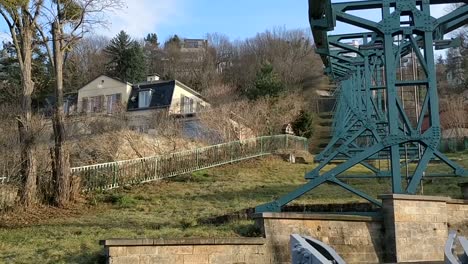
[104,30,146,83]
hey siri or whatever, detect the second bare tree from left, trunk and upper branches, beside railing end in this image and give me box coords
[34,0,121,206]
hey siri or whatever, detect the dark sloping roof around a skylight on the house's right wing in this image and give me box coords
[127,81,176,111]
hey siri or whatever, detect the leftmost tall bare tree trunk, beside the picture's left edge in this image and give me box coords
[17,15,37,207]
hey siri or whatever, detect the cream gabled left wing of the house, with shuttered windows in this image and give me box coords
[78,75,132,114]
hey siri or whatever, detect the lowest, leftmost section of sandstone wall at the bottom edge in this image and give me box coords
[101,238,270,264]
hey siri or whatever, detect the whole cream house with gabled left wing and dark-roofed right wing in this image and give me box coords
[77,75,209,132]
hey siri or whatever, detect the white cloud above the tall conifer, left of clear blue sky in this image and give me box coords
[97,0,184,38]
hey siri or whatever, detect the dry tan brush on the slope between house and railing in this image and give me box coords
[68,113,202,167]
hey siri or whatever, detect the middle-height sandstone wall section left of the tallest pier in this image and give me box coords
[256,213,383,263]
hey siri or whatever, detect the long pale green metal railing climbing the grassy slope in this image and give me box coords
[71,135,307,191]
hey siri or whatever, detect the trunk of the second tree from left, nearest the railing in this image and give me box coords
[52,21,71,207]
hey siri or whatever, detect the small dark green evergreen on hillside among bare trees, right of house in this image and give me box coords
[246,63,285,100]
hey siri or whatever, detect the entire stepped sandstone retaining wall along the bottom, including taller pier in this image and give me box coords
[101,195,468,264]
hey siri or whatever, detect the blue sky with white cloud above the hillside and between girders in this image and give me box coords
[96,0,456,41]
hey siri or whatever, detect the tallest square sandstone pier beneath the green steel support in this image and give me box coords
[380,194,448,263]
